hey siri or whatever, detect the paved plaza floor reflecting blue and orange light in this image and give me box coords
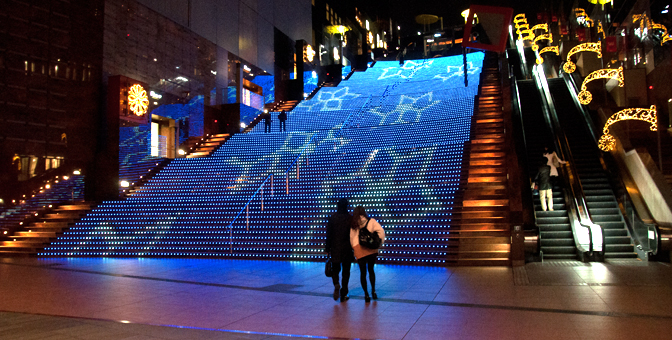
[0,259,672,339]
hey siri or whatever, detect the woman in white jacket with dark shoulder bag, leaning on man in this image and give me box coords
[350,205,385,302]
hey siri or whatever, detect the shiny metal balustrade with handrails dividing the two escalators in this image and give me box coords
[533,66,605,254]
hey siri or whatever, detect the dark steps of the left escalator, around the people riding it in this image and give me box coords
[517,80,577,260]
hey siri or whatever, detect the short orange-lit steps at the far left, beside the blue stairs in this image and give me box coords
[0,202,95,257]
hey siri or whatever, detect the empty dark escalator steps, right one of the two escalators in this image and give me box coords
[548,78,637,258]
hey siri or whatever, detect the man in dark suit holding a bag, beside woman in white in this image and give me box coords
[324,198,353,302]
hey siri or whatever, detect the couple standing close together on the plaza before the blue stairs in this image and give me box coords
[325,198,385,302]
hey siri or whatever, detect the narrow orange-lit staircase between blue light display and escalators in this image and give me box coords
[460,57,511,265]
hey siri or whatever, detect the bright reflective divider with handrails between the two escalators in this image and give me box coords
[533,65,605,260]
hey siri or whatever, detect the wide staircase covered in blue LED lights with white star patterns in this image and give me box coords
[41,53,483,264]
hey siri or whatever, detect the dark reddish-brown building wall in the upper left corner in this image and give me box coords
[0,0,103,198]
